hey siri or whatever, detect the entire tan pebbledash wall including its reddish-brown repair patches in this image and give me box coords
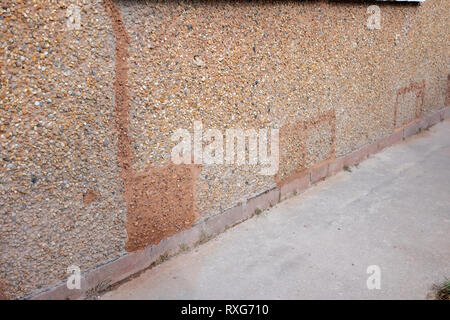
[0,0,450,298]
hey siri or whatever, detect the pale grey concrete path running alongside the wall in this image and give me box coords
[101,121,450,299]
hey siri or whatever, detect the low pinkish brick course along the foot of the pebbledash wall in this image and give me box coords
[27,107,450,300]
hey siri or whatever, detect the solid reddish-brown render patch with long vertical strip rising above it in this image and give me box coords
[103,0,198,251]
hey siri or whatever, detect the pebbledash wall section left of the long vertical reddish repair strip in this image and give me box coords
[0,1,126,297]
